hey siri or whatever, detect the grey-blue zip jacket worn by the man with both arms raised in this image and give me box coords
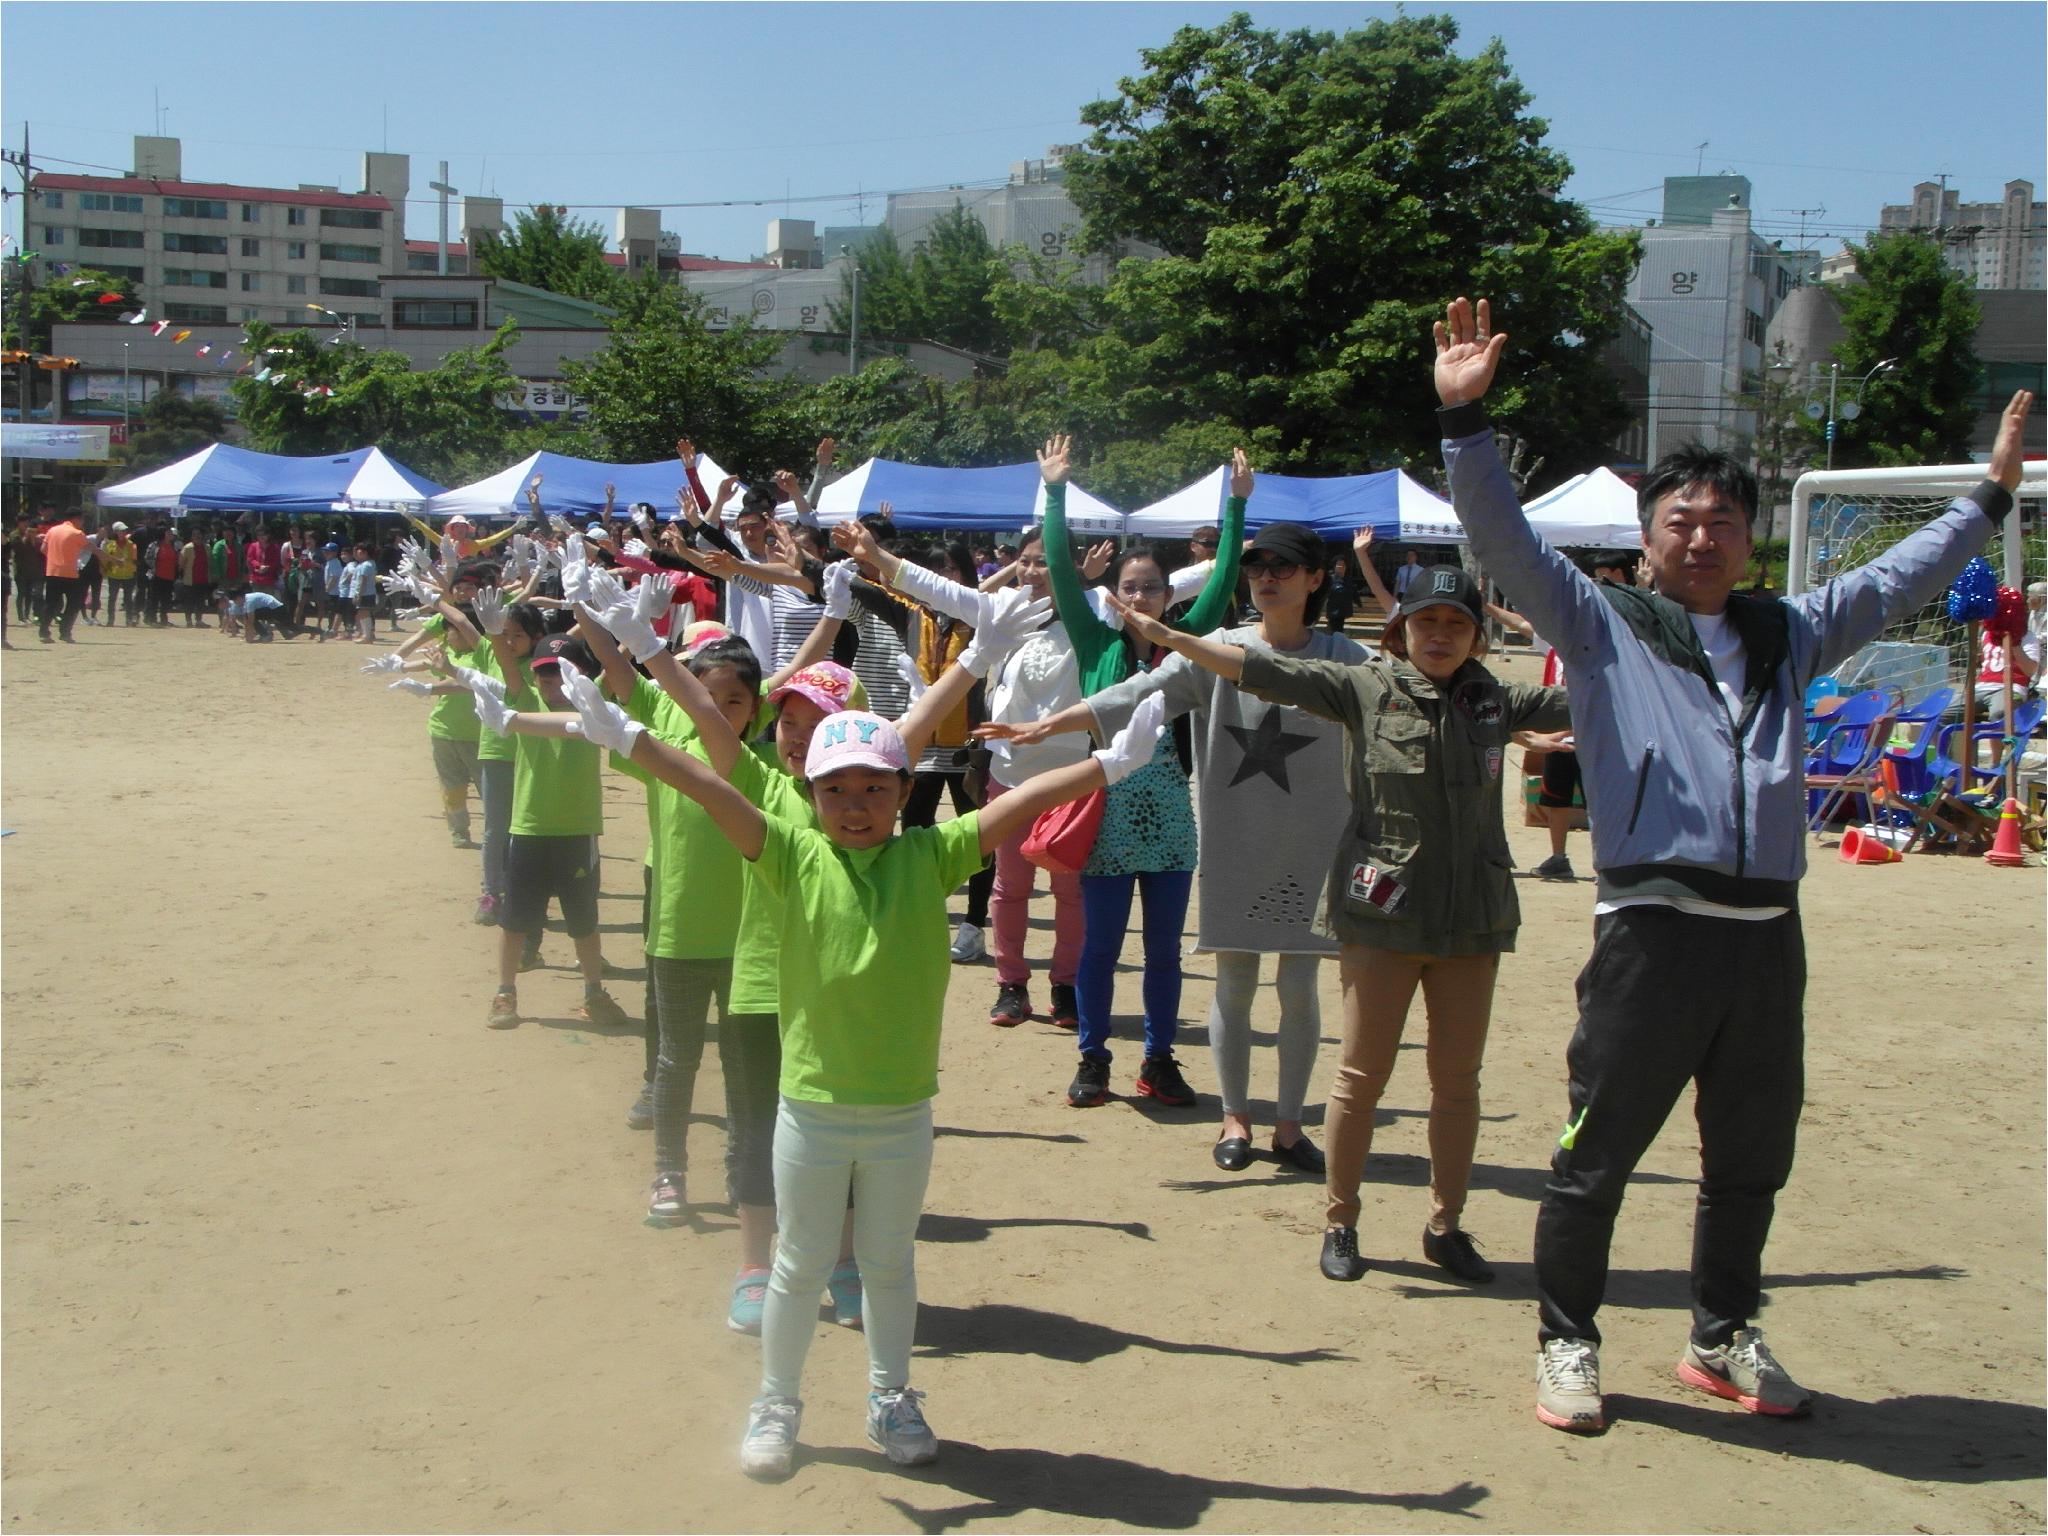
[1438,401,2013,907]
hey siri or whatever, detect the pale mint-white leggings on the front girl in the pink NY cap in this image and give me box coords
[762,1098,932,1397]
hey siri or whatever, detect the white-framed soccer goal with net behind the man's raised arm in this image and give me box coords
[1786,463,2048,702]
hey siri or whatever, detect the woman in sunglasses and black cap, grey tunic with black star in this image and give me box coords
[987,522,1372,1178]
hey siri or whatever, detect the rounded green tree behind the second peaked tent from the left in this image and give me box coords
[563,283,815,475]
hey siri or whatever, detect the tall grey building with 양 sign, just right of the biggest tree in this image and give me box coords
[1628,176,1817,459]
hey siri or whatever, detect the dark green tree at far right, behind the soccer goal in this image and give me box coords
[1819,229,1980,469]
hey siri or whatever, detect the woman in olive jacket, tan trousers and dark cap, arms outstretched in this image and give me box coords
[1116,565,1571,1284]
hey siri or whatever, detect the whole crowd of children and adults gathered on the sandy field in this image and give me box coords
[16,299,2032,1477]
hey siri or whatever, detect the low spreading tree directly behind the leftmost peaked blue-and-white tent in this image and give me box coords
[231,322,528,485]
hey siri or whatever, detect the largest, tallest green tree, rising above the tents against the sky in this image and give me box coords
[1067,14,1636,473]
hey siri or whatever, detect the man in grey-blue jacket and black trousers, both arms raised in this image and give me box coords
[1436,299,2034,1434]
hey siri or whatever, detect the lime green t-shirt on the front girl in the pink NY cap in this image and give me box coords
[754,811,981,1104]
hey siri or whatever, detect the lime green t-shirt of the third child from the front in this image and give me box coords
[612,678,745,961]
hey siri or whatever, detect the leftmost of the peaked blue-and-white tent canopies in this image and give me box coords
[94,442,440,516]
